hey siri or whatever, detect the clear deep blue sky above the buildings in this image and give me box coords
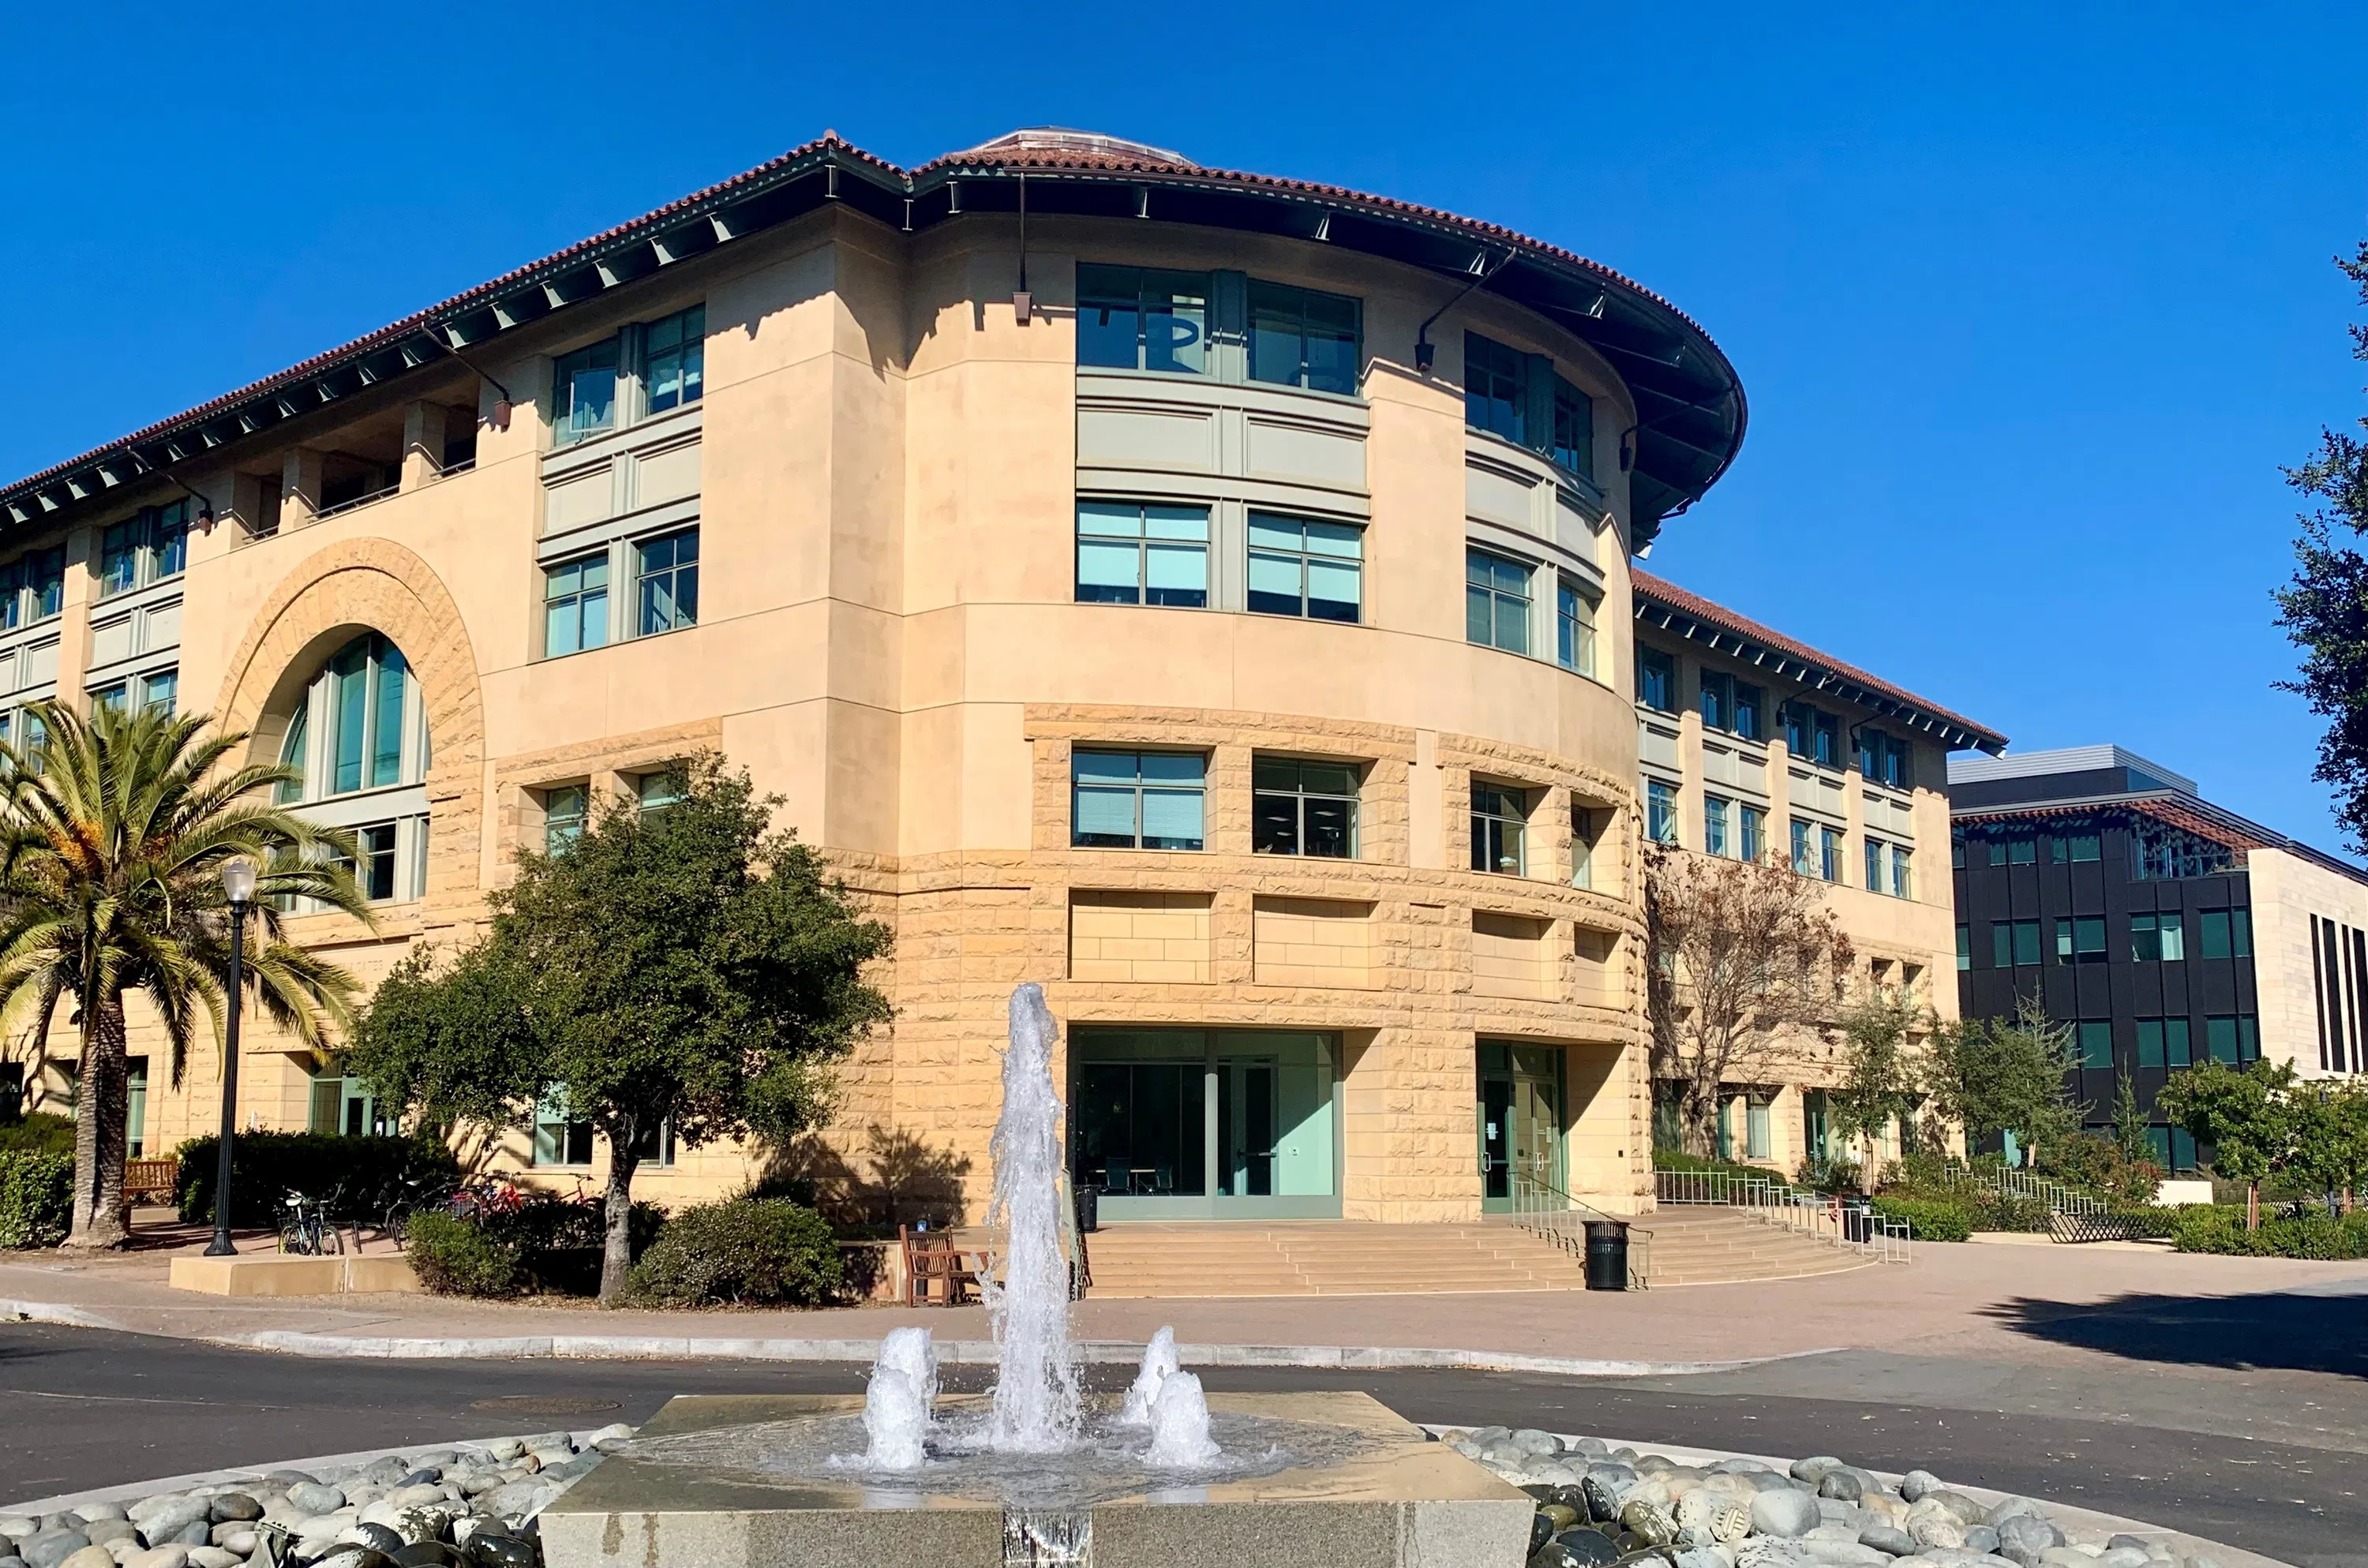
[0,0,2368,848]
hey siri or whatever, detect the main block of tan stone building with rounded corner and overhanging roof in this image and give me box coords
[0,133,1999,1220]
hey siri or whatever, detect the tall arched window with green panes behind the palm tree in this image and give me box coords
[279,632,429,903]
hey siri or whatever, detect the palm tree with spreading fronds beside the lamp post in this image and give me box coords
[0,703,372,1248]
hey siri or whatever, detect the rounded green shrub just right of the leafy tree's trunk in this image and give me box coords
[632,1199,845,1308]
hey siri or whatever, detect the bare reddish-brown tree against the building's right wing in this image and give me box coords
[1643,844,1852,1156]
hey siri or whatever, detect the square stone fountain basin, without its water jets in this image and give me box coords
[540,1393,1534,1568]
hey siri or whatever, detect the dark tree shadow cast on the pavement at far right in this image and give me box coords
[1984,1279,2368,1379]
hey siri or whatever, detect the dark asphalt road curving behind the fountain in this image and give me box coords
[0,1324,2368,1568]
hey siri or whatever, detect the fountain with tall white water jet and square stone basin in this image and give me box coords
[540,986,1532,1568]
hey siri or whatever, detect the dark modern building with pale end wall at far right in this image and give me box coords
[1949,746,2368,1170]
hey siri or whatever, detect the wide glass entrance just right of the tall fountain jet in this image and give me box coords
[1068,1028,1340,1220]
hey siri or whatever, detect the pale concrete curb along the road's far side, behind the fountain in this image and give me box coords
[0,1298,1840,1379]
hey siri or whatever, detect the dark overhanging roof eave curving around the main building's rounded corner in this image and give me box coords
[0,133,1748,547]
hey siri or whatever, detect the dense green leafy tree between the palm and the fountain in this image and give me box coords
[348,753,888,1303]
